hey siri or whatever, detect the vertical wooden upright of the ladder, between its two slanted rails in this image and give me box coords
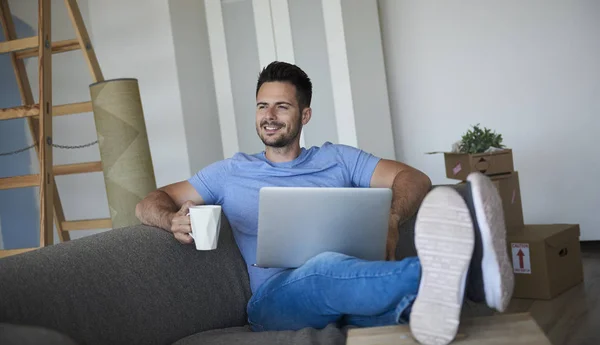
[38,0,55,247]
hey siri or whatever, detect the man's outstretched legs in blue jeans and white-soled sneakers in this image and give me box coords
[248,173,514,344]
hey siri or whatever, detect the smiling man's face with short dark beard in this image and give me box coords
[256,82,309,147]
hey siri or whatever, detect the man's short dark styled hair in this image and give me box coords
[256,61,312,111]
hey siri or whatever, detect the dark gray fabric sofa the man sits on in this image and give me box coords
[0,211,414,345]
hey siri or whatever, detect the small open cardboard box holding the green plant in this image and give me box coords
[444,149,514,181]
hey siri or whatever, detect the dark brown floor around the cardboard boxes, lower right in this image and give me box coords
[463,242,600,345]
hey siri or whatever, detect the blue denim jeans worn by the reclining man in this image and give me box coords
[247,252,421,331]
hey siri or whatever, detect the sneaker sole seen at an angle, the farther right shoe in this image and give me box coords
[467,173,514,312]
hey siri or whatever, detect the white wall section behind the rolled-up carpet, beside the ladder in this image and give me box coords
[88,0,191,186]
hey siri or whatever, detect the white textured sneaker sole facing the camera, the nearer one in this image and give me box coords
[410,187,475,345]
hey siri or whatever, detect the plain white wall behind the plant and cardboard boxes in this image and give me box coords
[380,0,600,240]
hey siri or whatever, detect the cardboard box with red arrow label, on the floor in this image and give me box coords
[507,224,583,299]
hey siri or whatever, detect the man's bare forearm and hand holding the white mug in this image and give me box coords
[135,181,204,232]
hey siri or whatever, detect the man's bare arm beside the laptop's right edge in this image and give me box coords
[371,159,431,260]
